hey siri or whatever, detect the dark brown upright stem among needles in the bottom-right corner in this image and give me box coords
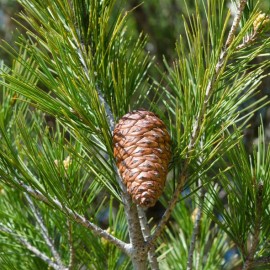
[243,183,263,270]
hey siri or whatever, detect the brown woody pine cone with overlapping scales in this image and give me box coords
[113,109,171,207]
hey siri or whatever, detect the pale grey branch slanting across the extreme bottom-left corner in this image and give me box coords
[0,223,68,270]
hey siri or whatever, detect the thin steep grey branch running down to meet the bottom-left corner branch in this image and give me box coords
[25,194,64,268]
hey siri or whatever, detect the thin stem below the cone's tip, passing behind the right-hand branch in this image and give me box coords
[137,205,159,270]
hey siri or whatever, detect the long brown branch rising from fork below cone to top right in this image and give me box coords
[147,0,247,251]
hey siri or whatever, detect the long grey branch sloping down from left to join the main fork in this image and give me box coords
[17,182,131,256]
